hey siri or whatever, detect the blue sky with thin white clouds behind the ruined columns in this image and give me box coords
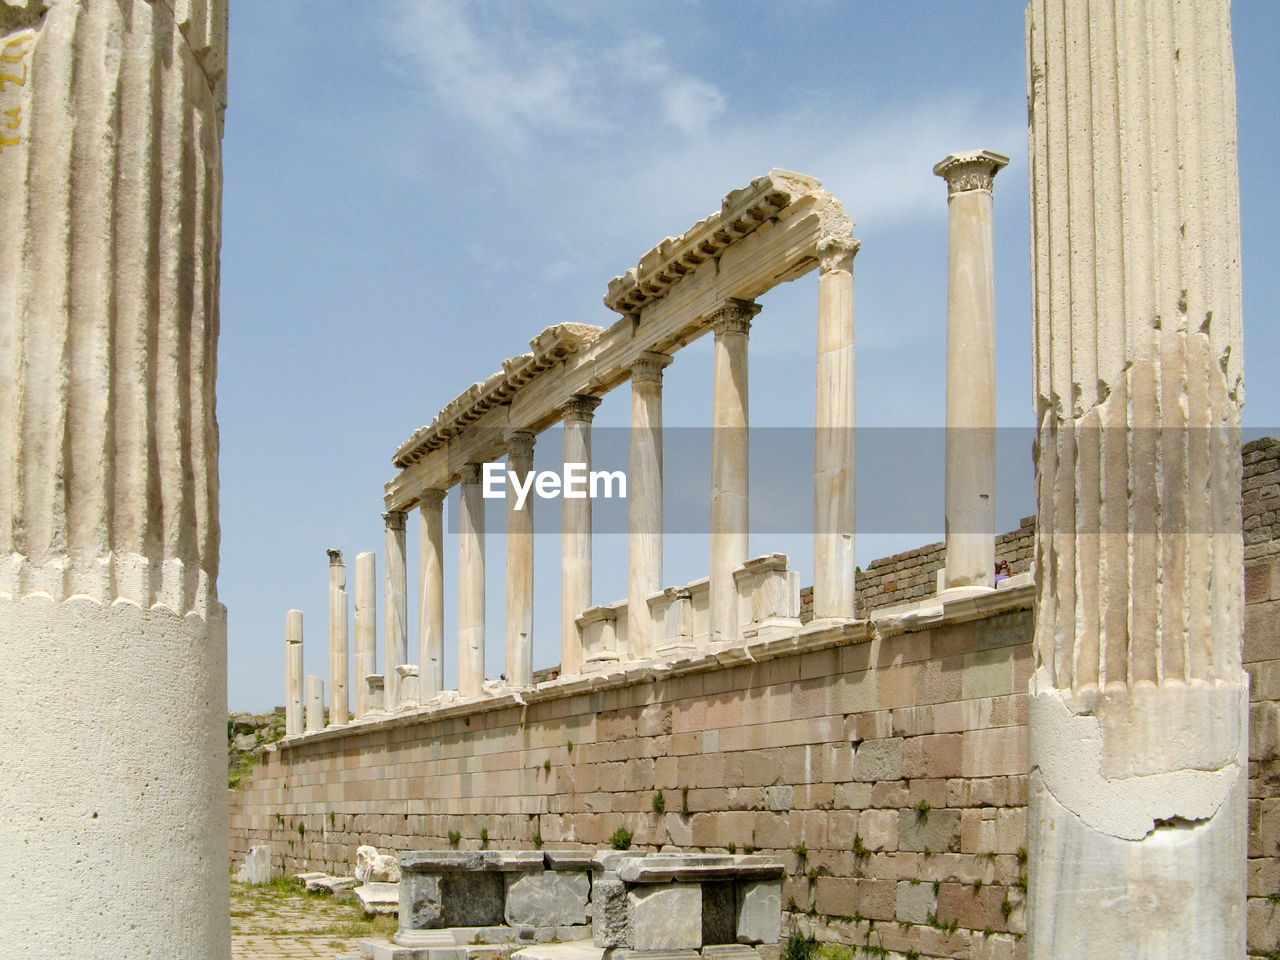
[218,0,1280,710]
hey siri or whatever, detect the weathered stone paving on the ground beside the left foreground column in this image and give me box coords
[232,881,396,960]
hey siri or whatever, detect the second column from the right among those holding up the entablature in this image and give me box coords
[708,300,760,643]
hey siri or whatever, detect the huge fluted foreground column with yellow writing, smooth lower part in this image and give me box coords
[0,0,230,960]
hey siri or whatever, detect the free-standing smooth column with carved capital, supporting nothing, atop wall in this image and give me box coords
[933,150,1009,589]
